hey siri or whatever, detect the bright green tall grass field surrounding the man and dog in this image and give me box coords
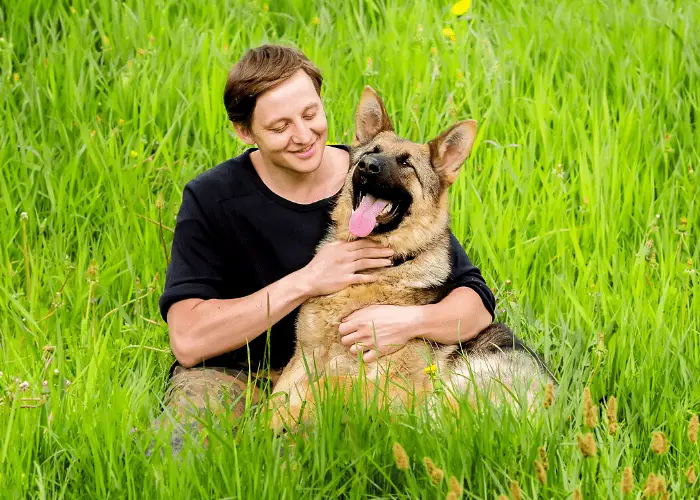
[0,0,700,499]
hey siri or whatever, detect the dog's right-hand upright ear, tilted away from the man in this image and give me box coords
[428,120,476,186]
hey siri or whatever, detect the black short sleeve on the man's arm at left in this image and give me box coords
[158,184,224,321]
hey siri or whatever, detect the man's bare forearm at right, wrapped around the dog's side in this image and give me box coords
[412,287,493,344]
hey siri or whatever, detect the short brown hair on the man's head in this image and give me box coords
[224,45,323,130]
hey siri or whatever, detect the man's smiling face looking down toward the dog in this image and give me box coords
[239,70,328,173]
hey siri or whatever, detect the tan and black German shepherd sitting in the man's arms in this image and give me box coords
[272,86,552,431]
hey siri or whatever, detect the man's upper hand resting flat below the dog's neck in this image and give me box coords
[301,239,394,297]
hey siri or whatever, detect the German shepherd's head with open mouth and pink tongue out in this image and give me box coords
[333,86,476,256]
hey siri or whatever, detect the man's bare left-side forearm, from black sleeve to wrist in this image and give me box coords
[168,271,309,367]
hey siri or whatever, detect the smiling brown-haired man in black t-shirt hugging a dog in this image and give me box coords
[154,45,495,446]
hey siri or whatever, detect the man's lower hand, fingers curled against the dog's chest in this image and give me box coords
[339,306,423,363]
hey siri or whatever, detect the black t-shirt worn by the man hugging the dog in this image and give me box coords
[159,145,495,368]
